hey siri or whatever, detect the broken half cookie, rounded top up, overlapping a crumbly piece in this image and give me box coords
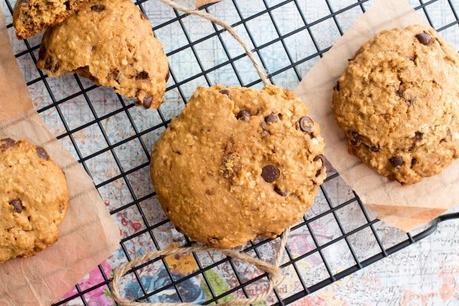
[38,0,169,108]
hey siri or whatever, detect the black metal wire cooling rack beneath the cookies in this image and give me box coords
[5,0,459,305]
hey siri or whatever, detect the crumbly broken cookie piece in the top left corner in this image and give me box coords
[13,0,89,39]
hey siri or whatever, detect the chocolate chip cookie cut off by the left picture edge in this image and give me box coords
[0,138,69,262]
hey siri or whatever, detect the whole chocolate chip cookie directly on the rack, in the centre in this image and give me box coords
[151,86,326,248]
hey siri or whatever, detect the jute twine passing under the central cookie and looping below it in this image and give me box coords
[111,0,290,306]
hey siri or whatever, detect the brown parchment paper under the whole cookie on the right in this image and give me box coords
[297,0,459,231]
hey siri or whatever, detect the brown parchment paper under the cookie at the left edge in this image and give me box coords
[0,10,119,306]
